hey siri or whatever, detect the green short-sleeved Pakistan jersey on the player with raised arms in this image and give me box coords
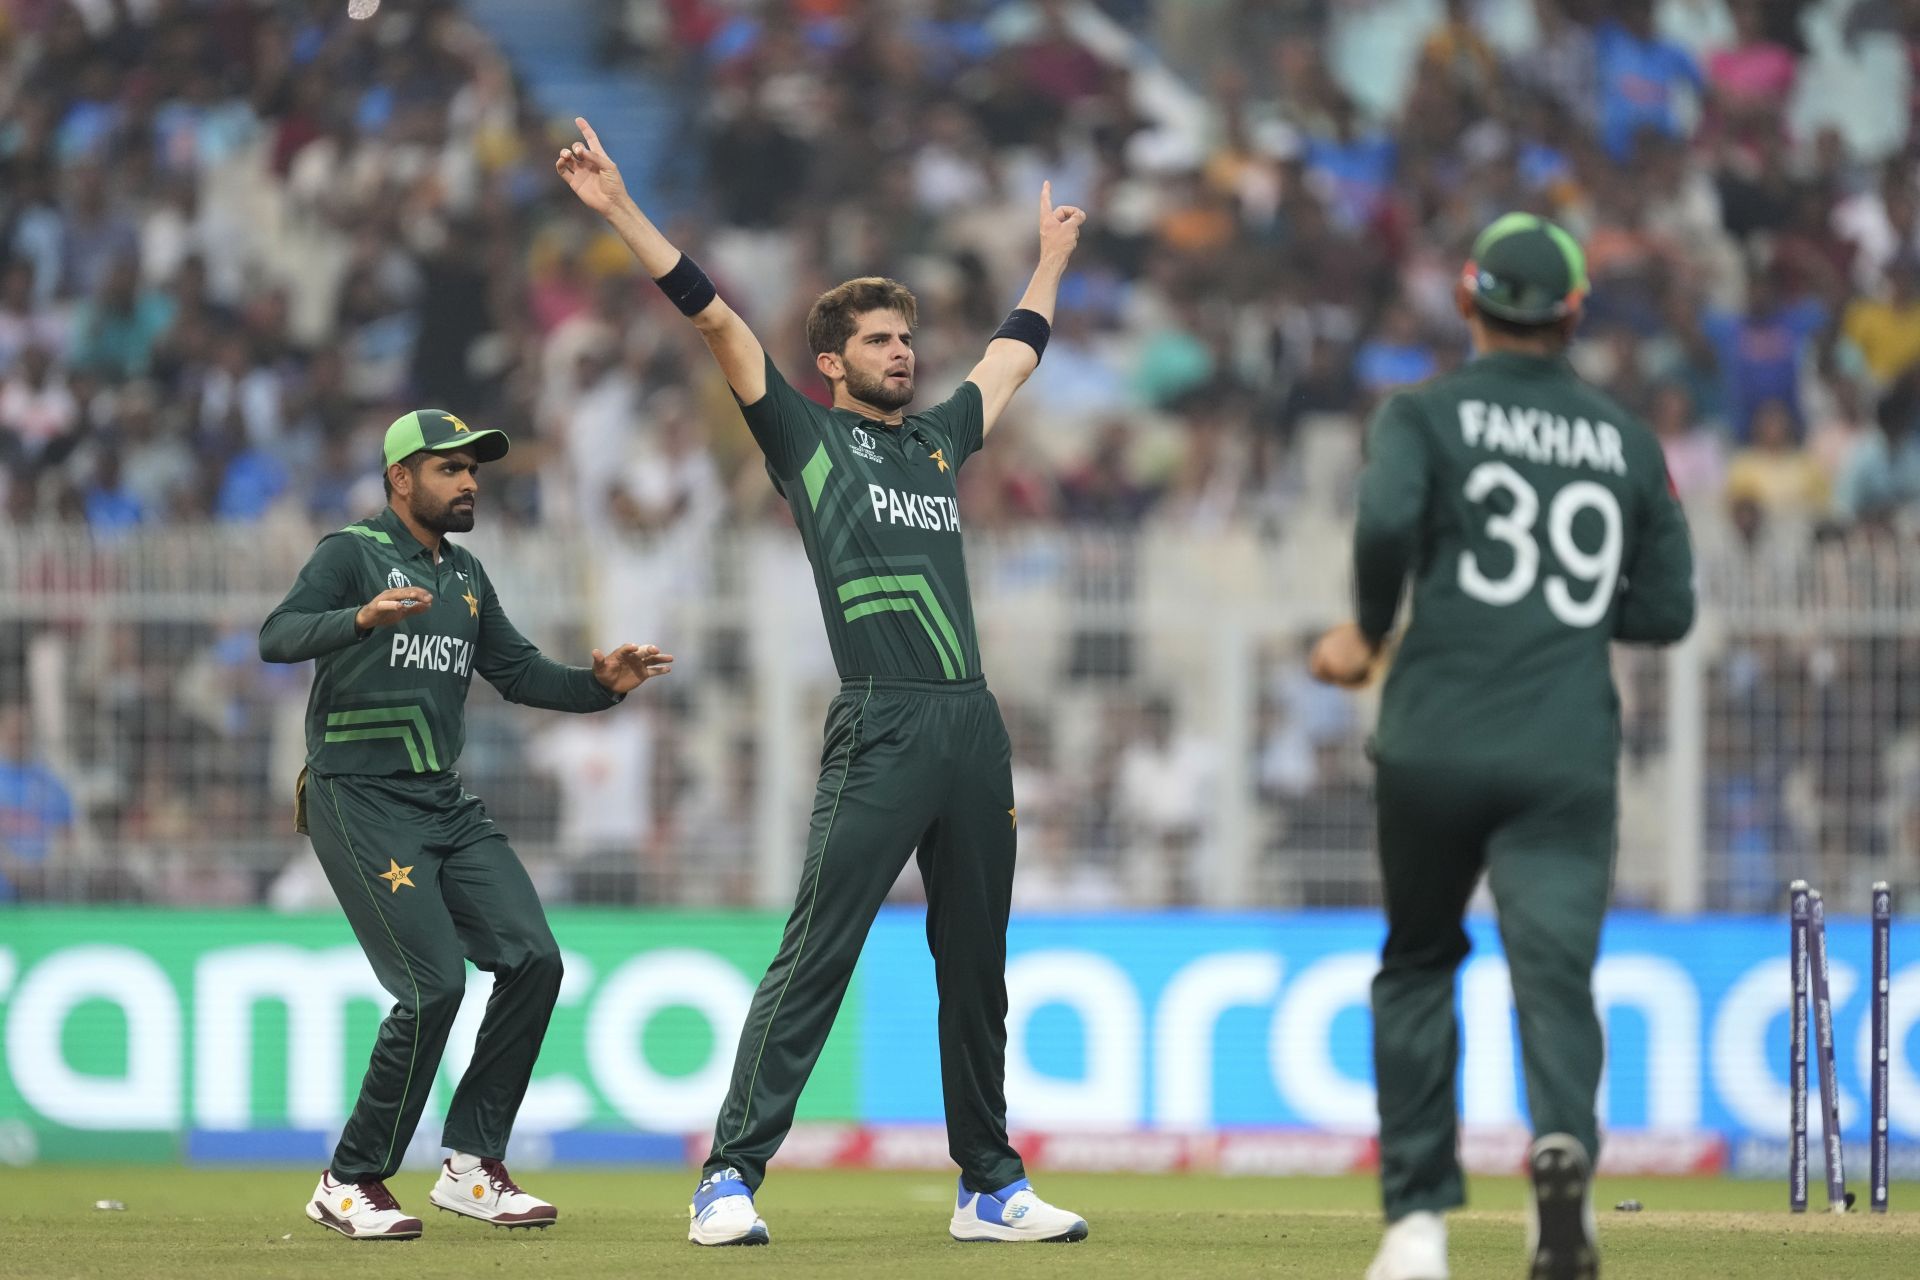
[741,359,985,679]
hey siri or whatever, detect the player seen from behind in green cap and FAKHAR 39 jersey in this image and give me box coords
[1311,213,1693,1280]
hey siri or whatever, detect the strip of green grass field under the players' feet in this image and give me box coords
[0,1167,1920,1280]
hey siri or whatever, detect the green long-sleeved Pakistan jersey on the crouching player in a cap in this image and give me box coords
[259,509,620,775]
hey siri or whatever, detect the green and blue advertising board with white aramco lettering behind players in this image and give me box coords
[0,908,1920,1167]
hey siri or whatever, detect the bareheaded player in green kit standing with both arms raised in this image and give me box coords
[555,119,1087,1245]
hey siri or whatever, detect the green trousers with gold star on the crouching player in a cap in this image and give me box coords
[300,771,561,1182]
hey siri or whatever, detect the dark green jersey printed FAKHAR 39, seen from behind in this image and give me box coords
[1354,353,1693,775]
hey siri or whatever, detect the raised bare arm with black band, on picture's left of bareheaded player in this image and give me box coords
[553,115,766,405]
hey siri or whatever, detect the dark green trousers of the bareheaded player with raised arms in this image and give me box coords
[705,677,1025,1192]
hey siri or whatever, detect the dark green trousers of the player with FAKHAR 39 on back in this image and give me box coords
[1373,762,1619,1221]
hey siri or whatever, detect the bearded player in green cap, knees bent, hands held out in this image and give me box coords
[259,409,672,1240]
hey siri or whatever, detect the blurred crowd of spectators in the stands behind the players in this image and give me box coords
[0,0,1920,904]
